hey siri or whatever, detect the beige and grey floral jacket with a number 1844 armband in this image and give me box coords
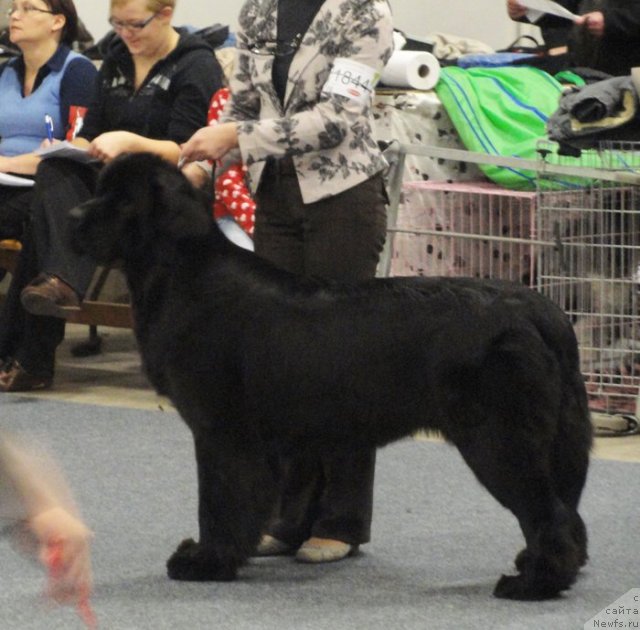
[221,0,393,203]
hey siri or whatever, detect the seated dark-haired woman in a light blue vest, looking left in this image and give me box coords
[0,0,97,240]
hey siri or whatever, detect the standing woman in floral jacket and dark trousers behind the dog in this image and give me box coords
[182,0,393,562]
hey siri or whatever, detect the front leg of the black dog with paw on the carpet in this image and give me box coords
[167,432,275,581]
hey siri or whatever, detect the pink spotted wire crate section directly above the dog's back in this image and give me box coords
[388,181,536,285]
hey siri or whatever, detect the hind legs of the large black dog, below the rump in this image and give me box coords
[457,426,580,600]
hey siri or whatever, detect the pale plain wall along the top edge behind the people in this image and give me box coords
[75,0,517,48]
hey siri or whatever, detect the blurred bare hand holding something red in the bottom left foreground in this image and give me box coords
[29,507,93,604]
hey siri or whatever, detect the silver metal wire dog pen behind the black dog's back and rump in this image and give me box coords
[380,143,640,435]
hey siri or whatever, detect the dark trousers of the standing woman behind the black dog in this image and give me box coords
[254,160,386,546]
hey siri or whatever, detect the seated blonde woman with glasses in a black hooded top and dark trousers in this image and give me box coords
[0,0,223,391]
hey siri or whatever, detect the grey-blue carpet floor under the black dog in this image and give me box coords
[0,402,640,630]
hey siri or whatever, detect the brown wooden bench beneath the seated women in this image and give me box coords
[0,240,133,328]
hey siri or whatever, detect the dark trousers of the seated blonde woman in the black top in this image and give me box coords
[0,159,99,375]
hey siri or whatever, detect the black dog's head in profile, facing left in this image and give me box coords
[69,153,213,265]
